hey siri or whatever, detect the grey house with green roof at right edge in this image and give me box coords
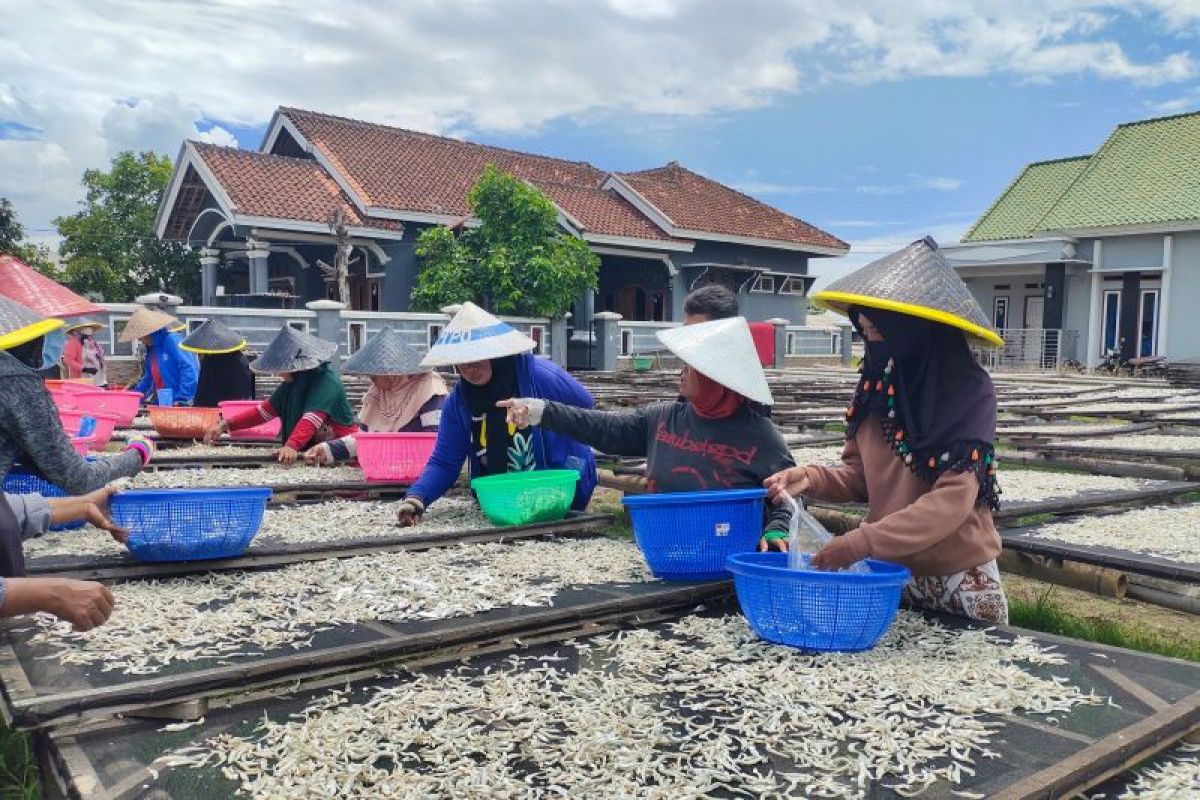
[943,113,1200,365]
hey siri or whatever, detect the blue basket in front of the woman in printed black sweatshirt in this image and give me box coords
[623,489,767,581]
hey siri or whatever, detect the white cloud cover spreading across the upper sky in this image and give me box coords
[0,0,1200,237]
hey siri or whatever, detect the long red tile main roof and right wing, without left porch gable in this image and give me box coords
[280,108,848,248]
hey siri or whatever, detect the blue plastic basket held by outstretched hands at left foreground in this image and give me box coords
[112,487,271,561]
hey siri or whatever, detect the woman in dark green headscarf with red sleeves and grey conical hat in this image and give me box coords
[204,325,355,464]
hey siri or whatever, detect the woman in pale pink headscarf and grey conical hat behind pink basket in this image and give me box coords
[304,327,449,464]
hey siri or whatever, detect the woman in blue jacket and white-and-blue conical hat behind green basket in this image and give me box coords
[397,302,596,525]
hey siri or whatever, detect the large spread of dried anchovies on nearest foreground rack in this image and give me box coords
[164,612,1103,798]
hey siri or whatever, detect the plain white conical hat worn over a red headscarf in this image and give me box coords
[658,317,775,405]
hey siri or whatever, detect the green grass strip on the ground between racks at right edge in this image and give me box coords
[1008,590,1200,661]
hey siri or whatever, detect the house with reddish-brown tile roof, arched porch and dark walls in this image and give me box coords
[157,108,850,340]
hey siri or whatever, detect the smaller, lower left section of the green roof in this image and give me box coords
[962,156,1088,241]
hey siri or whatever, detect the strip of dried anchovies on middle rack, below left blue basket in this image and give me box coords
[31,539,649,674]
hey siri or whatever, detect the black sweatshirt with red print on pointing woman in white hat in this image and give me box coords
[541,402,796,530]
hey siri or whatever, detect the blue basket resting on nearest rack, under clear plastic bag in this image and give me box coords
[728,553,911,652]
